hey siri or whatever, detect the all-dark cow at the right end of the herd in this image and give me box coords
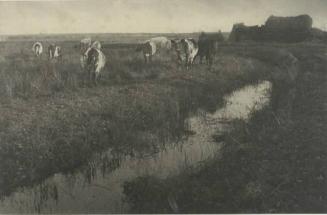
[197,32,224,66]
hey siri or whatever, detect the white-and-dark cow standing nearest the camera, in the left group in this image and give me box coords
[84,47,106,85]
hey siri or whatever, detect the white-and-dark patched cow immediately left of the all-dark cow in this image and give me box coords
[171,38,199,69]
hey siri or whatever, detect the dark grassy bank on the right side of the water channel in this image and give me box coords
[124,45,327,213]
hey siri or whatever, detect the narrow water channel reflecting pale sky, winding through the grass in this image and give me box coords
[0,82,271,213]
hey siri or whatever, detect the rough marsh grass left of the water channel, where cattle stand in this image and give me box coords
[0,38,267,195]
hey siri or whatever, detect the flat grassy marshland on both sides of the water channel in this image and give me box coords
[0,34,327,213]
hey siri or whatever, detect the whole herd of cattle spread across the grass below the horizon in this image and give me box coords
[32,33,224,84]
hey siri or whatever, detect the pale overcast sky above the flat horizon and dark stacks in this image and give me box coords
[0,0,327,34]
